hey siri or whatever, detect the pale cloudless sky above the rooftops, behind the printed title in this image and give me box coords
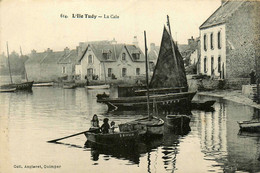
[0,0,221,54]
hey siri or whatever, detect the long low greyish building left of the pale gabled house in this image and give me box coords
[25,47,78,81]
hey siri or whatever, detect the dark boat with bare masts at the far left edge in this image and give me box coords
[0,43,33,92]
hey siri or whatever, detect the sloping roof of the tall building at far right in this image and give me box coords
[200,0,246,29]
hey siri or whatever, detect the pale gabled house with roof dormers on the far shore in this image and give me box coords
[76,42,145,80]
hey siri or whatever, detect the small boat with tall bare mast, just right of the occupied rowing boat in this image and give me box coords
[119,31,164,136]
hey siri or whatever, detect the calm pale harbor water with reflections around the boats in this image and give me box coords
[0,78,260,173]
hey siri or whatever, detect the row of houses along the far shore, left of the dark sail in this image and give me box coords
[25,37,152,81]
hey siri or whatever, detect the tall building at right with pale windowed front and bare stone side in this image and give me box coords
[199,0,260,79]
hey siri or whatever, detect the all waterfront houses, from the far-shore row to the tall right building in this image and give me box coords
[25,0,260,81]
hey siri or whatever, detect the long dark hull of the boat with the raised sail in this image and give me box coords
[97,92,196,110]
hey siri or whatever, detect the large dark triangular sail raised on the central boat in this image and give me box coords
[149,27,188,88]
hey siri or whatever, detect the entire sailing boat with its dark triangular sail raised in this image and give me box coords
[97,16,196,110]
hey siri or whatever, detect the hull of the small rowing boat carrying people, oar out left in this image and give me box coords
[84,130,138,145]
